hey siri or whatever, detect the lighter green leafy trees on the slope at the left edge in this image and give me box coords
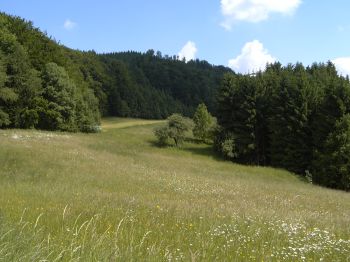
[0,13,103,131]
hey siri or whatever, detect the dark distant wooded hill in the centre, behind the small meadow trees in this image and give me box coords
[101,50,232,118]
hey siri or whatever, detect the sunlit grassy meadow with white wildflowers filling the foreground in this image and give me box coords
[0,118,350,261]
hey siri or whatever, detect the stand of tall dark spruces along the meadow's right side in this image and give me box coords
[215,62,350,190]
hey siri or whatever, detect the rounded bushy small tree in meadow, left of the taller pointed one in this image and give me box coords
[154,114,193,146]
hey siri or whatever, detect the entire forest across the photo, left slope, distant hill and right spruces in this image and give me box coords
[0,13,350,190]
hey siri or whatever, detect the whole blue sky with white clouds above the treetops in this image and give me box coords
[0,0,350,75]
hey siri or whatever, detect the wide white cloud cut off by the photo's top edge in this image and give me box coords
[221,0,301,30]
